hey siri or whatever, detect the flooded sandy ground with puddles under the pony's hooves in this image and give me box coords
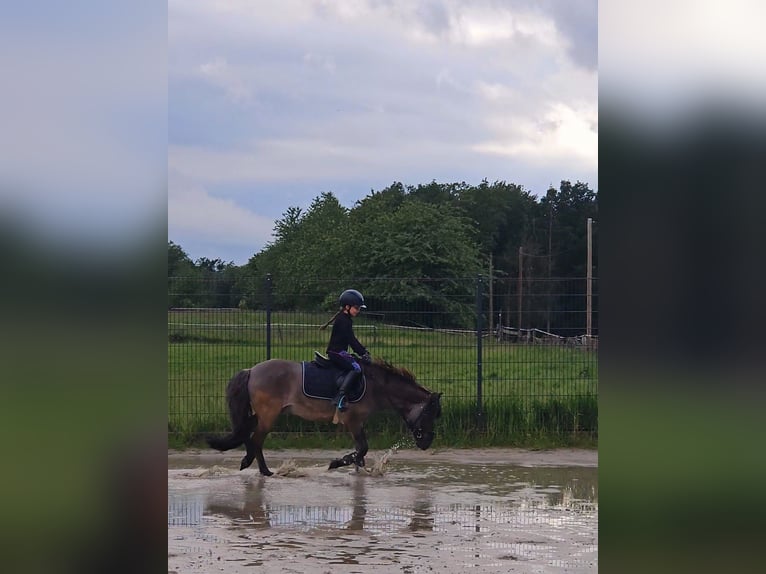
[168,449,598,574]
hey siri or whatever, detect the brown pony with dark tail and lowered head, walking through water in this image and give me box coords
[207,353,442,476]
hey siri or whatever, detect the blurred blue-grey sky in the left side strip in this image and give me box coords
[0,3,167,245]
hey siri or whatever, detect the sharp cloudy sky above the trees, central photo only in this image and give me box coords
[167,0,598,265]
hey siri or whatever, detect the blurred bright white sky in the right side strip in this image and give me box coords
[599,0,766,114]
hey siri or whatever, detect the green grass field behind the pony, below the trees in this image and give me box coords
[168,311,598,448]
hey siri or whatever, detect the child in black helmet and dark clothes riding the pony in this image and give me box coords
[327,289,372,411]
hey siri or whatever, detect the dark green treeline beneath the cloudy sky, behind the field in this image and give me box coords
[168,180,598,332]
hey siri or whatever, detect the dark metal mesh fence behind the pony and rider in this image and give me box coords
[168,276,598,435]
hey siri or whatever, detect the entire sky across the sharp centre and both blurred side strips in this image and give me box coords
[0,0,766,263]
